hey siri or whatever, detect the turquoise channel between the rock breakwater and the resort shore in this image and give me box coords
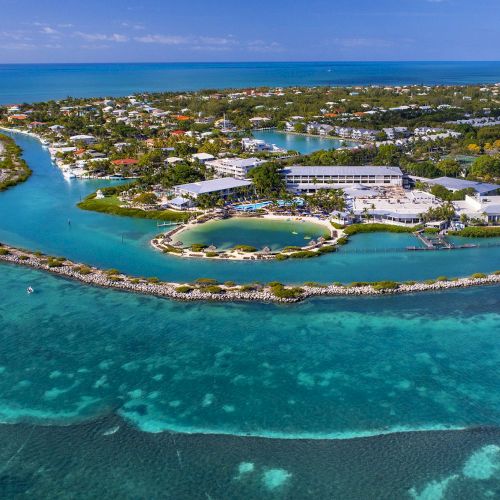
[0,134,500,283]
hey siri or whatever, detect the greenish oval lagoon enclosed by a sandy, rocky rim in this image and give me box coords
[173,217,330,250]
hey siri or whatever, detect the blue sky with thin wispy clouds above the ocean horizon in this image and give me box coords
[0,0,500,63]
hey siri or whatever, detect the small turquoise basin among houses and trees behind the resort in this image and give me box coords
[252,130,356,154]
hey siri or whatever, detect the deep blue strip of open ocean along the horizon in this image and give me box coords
[0,61,500,103]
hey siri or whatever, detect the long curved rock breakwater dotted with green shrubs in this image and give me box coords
[0,245,500,304]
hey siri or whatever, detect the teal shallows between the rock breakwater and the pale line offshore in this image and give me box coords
[0,264,500,438]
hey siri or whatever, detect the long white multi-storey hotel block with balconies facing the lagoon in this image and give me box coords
[282,166,403,194]
